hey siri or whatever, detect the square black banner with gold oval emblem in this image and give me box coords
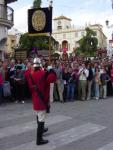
[28,7,52,34]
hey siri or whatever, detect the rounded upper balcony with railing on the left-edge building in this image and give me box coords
[0,4,14,29]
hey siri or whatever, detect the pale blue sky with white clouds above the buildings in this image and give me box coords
[9,0,113,38]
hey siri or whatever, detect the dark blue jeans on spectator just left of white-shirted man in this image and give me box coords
[66,83,75,100]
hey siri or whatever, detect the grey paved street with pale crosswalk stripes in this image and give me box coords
[0,98,113,150]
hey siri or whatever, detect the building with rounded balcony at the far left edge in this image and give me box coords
[0,0,17,60]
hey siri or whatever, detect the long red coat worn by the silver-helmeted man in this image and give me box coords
[27,70,56,110]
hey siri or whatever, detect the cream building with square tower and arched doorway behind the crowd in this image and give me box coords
[52,16,107,52]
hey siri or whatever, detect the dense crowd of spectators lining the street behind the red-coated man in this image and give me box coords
[0,57,113,103]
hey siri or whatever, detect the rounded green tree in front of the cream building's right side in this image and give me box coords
[78,28,98,56]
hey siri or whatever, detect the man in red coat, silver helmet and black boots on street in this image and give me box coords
[27,58,56,145]
